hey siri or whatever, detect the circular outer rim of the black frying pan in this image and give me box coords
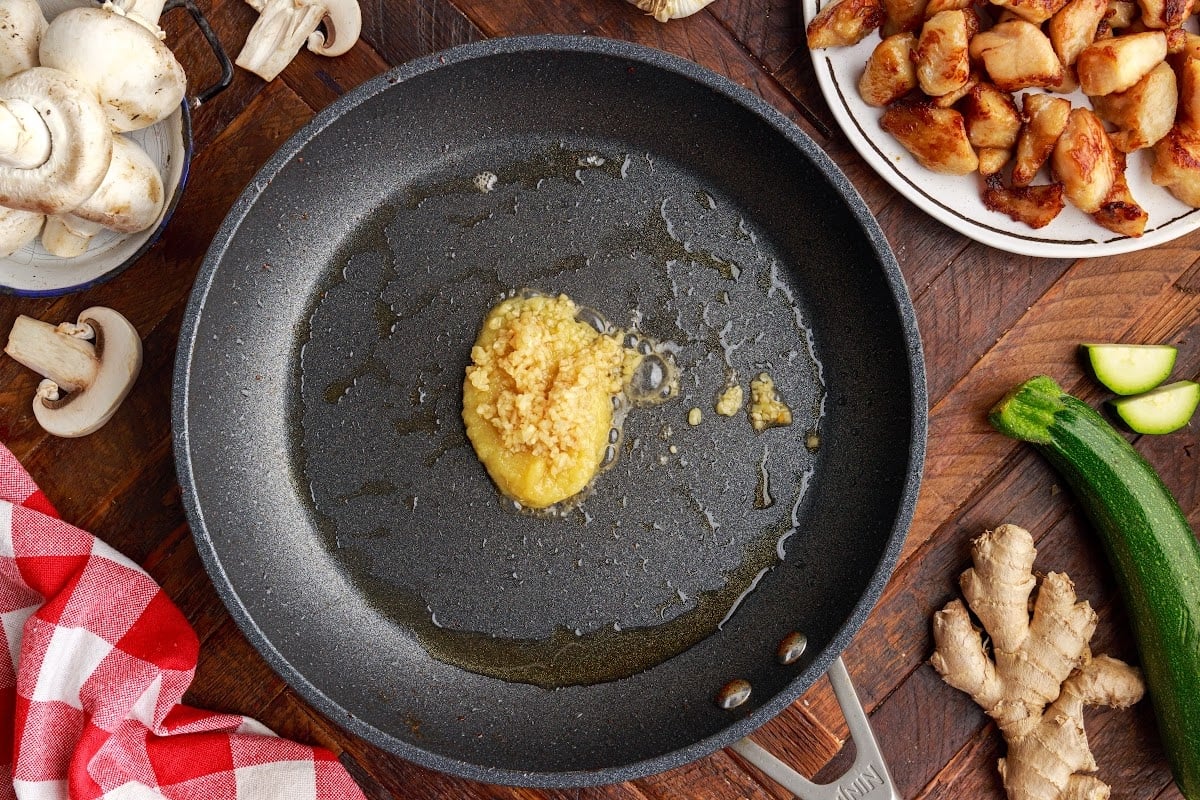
[172,35,929,788]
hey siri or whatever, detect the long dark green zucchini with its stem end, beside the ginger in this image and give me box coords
[989,377,1200,800]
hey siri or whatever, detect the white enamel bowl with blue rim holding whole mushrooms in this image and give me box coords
[0,0,187,296]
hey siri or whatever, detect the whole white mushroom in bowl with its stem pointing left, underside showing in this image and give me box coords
[0,67,113,213]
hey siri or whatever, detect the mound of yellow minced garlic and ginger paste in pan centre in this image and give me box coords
[462,295,629,509]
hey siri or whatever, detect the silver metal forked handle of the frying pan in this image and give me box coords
[732,657,901,800]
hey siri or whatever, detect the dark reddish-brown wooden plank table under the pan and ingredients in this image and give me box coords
[0,0,1200,800]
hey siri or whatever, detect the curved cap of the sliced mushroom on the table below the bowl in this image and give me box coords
[34,306,142,438]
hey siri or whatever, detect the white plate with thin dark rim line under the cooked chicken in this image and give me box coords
[804,0,1200,258]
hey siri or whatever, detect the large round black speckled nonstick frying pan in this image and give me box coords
[174,36,926,796]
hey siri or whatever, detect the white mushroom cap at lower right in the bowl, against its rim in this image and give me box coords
[71,136,166,234]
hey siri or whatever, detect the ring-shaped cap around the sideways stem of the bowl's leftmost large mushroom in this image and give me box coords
[0,67,113,213]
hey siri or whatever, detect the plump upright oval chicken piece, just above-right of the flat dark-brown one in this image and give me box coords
[1050,108,1117,213]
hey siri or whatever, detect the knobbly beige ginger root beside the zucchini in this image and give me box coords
[930,525,1145,800]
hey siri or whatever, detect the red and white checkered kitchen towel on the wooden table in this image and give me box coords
[0,445,362,800]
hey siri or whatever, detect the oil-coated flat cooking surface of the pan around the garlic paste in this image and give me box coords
[293,137,824,687]
